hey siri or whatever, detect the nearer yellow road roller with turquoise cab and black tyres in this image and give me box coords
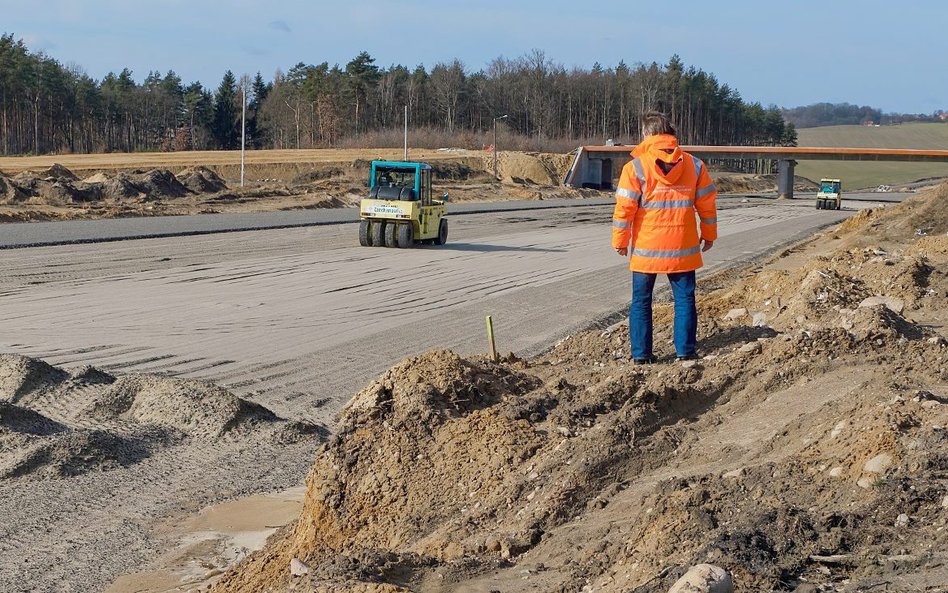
[359,161,448,248]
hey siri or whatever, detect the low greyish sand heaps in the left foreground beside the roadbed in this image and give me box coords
[0,354,320,478]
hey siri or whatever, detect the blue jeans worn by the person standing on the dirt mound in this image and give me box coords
[629,272,698,359]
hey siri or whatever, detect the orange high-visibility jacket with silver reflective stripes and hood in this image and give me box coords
[612,135,718,274]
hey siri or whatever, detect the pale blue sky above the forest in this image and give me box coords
[0,0,948,113]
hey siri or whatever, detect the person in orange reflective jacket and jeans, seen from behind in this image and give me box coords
[612,112,718,364]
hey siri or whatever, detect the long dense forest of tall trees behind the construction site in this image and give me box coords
[0,34,796,155]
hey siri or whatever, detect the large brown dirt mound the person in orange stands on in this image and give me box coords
[214,185,948,593]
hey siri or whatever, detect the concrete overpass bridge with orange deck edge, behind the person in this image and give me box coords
[564,146,948,198]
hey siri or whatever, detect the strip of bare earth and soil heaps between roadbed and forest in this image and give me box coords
[0,149,800,222]
